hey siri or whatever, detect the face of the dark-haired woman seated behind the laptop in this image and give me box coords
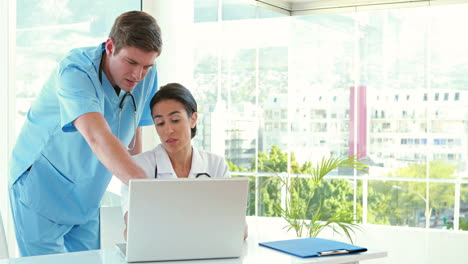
[151,99,198,153]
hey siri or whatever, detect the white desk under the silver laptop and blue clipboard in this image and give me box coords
[0,218,387,264]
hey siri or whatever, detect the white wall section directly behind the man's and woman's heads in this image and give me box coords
[143,0,193,151]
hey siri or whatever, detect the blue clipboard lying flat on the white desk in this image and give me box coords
[258,238,367,258]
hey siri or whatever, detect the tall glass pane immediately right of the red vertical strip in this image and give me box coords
[360,8,428,167]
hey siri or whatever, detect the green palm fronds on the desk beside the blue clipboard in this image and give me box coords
[271,157,367,242]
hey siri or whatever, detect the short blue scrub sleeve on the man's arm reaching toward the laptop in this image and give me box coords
[57,66,103,132]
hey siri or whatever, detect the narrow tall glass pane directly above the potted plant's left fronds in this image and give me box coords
[257,19,288,172]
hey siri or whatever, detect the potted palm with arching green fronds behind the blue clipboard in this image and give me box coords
[272,156,368,243]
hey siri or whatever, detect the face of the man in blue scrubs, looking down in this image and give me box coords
[103,39,159,92]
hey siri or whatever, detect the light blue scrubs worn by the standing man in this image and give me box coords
[9,44,157,256]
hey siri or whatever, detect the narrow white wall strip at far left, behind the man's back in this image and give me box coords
[0,0,16,256]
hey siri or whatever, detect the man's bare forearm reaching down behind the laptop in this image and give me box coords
[73,112,145,184]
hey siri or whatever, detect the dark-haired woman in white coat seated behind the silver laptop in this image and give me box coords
[122,83,247,240]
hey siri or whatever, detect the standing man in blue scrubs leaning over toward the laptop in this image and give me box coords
[9,11,162,256]
